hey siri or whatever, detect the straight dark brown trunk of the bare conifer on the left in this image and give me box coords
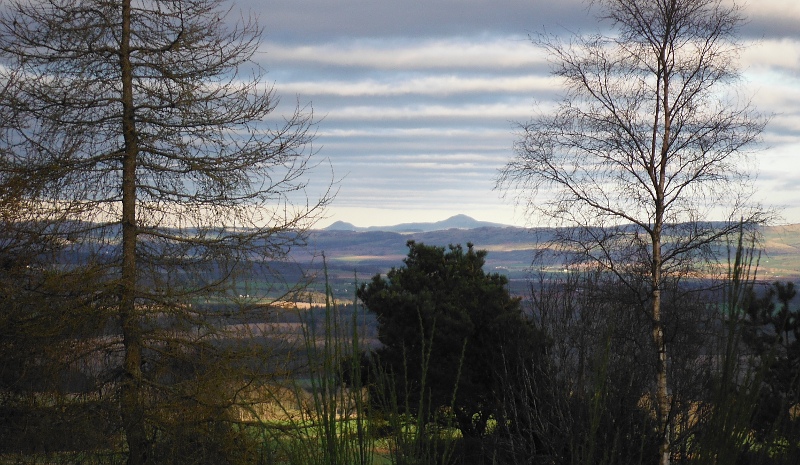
[119,0,148,465]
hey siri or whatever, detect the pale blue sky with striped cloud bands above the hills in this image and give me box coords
[247,0,800,227]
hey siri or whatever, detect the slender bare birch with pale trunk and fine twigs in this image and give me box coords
[498,0,765,464]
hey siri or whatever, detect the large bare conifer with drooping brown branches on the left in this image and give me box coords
[0,0,330,464]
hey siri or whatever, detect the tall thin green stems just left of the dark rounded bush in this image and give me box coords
[266,260,375,465]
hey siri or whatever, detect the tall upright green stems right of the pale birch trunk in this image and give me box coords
[690,224,800,465]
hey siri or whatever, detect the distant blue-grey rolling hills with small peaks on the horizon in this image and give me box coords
[295,215,800,294]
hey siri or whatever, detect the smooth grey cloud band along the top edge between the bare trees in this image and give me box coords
[247,0,594,42]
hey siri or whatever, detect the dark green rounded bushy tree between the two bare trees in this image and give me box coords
[358,241,543,438]
